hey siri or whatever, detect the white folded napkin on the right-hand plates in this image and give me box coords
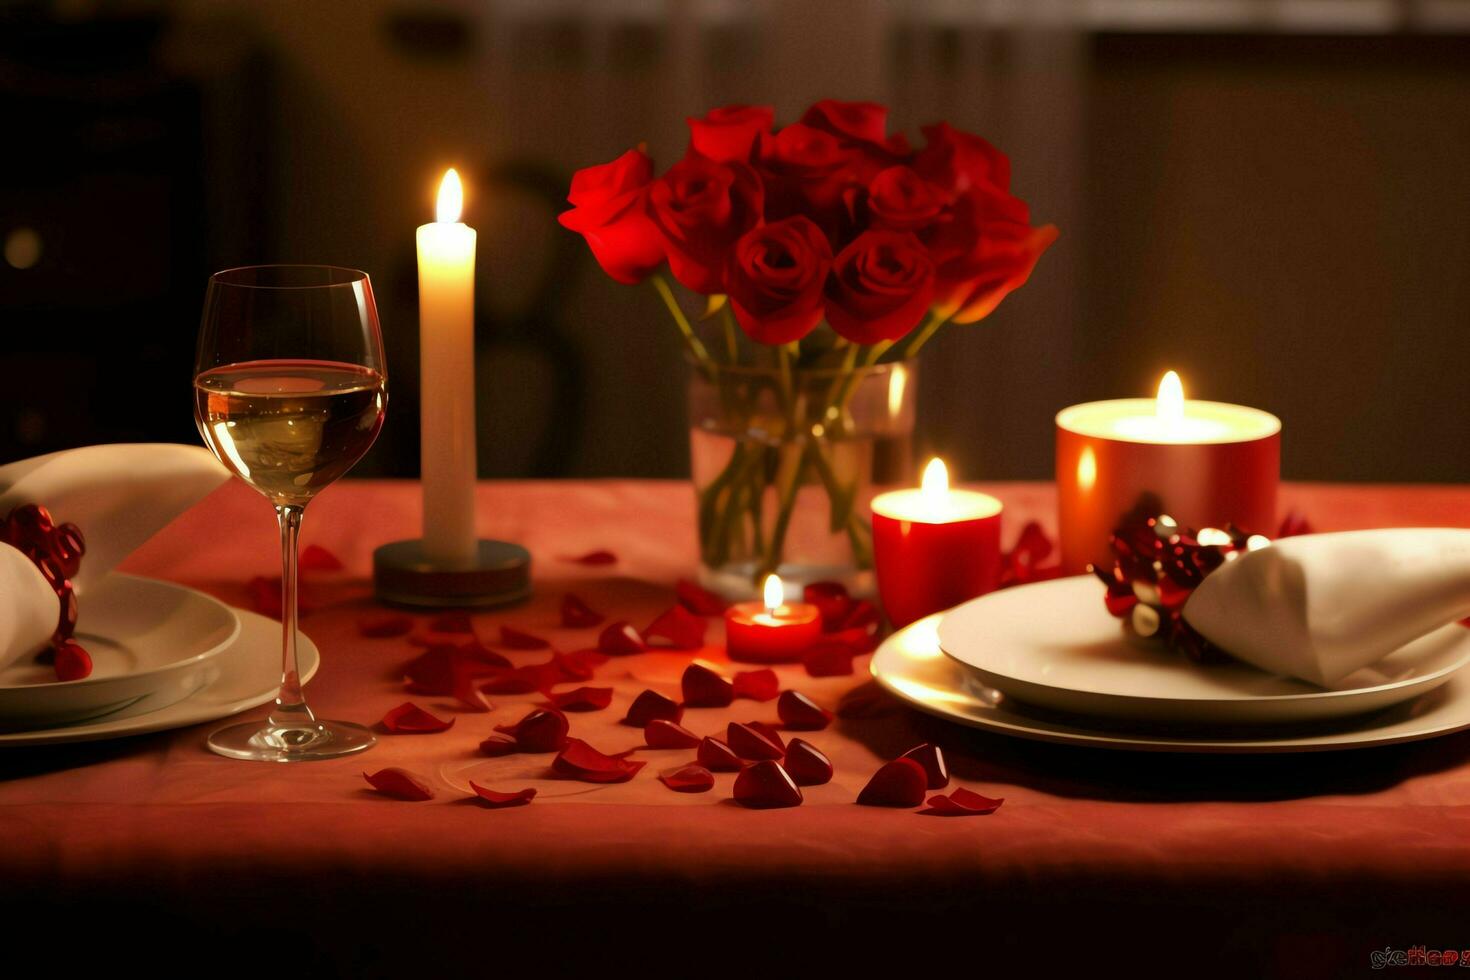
[1183,527,1470,688]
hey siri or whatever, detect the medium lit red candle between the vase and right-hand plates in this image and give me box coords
[873,458,1001,629]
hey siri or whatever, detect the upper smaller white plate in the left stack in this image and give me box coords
[0,574,240,732]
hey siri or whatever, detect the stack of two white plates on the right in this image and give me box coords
[872,576,1470,752]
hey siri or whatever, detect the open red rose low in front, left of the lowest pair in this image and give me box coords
[725,215,832,344]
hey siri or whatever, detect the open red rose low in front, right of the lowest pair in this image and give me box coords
[826,231,933,344]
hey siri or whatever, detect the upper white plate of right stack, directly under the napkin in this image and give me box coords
[939,574,1470,724]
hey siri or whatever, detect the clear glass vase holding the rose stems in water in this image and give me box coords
[689,354,917,599]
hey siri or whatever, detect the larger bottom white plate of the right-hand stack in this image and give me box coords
[869,613,1470,754]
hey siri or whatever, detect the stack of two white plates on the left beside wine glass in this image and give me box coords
[0,573,320,748]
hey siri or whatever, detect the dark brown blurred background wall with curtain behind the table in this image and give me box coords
[0,0,1470,482]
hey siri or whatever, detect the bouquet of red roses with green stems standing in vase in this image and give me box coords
[560,100,1057,590]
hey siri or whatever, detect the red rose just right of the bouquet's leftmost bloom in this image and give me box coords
[648,156,764,294]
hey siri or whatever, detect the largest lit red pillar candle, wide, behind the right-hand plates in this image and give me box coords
[1057,372,1282,574]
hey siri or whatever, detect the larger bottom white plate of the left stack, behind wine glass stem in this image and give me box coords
[0,610,322,748]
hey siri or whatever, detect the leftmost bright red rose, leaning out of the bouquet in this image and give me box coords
[559,150,663,284]
